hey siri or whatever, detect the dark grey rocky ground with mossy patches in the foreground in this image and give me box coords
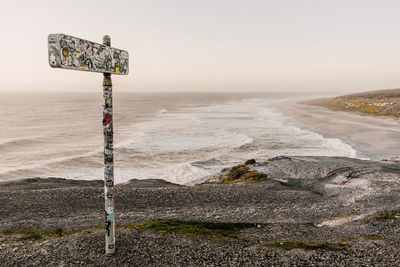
[0,157,400,266]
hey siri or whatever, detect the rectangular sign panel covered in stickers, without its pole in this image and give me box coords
[48,34,129,75]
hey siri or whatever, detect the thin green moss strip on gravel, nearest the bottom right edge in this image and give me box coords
[266,241,348,250]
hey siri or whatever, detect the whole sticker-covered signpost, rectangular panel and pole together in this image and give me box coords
[48,34,129,254]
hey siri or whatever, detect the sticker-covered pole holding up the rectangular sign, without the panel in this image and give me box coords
[103,35,115,255]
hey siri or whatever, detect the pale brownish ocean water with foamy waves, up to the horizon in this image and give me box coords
[0,92,357,185]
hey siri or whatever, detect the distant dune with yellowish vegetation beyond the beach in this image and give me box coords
[304,89,400,118]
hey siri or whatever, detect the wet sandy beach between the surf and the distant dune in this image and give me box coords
[273,100,400,160]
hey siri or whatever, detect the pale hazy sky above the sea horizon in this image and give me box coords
[0,0,400,92]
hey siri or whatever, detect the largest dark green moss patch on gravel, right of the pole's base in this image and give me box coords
[138,220,257,239]
